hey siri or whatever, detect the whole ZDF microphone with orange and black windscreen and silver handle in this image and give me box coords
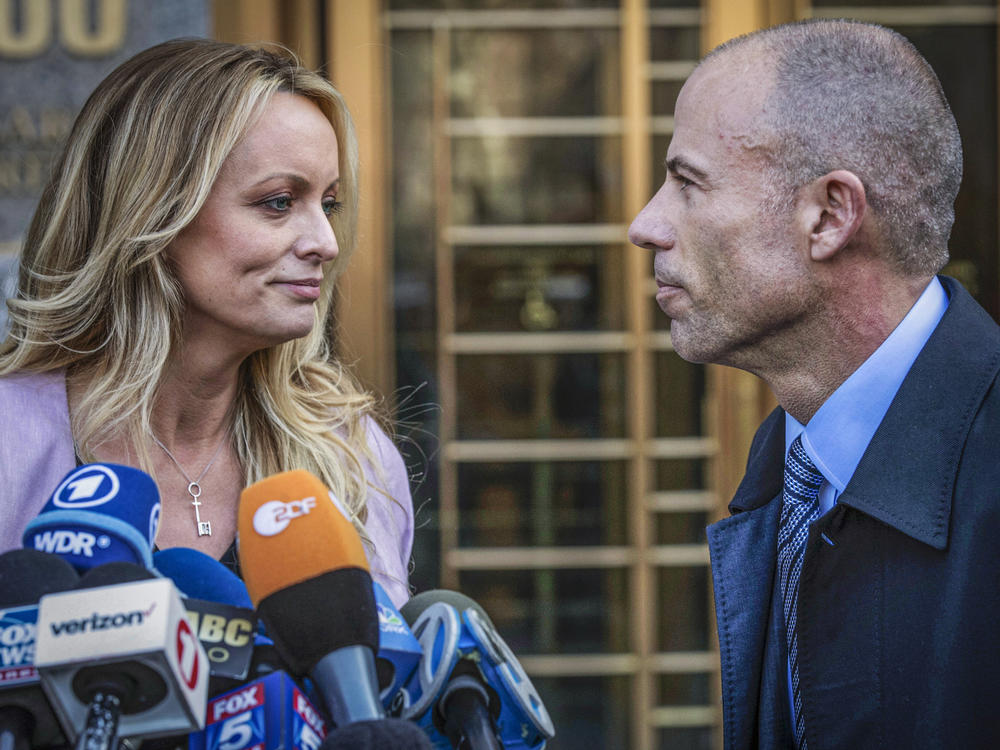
[239,470,385,727]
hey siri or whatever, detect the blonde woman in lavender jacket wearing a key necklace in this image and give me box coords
[0,40,413,605]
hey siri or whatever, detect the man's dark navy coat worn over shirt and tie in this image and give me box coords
[708,277,1000,750]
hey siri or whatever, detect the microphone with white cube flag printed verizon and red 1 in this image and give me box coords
[35,562,209,748]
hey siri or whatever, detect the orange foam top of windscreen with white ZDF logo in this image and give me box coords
[238,469,370,607]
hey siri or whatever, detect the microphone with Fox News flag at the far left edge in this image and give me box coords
[0,549,79,750]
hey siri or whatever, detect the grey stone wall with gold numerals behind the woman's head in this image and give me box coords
[0,0,211,336]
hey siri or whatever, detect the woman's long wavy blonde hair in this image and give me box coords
[0,39,390,538]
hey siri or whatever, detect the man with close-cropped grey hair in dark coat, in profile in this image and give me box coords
[629,21,1000,750]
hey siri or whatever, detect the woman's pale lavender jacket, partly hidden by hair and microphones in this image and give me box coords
[0,370,413,607]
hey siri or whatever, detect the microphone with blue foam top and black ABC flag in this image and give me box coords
[153,547,257,695]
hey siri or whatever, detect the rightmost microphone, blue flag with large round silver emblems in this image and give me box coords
[402,590,555,750]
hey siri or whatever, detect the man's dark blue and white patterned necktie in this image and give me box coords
[778,436,823,750]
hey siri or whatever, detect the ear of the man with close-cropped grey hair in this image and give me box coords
[799,169,868,262]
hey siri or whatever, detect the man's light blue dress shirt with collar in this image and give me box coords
[785,278,948,726]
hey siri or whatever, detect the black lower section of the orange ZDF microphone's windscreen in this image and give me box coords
[257,568,378,676]
